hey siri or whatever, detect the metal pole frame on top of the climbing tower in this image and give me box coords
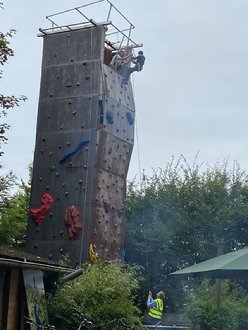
[38,0,143,50]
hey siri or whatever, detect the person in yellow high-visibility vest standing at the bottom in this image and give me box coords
[147,291,165,324]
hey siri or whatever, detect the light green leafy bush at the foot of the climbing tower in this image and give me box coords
[48,261,141,330]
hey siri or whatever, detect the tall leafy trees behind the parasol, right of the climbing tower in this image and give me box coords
[125,156,248,309]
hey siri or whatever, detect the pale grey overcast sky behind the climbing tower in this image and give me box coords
[0,0,248,184]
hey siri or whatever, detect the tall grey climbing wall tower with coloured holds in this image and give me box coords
[26,25,134,267]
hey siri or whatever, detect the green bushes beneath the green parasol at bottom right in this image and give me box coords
[186,281,248,330]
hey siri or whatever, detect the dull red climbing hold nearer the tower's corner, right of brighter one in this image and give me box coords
[65,205,83,239]
